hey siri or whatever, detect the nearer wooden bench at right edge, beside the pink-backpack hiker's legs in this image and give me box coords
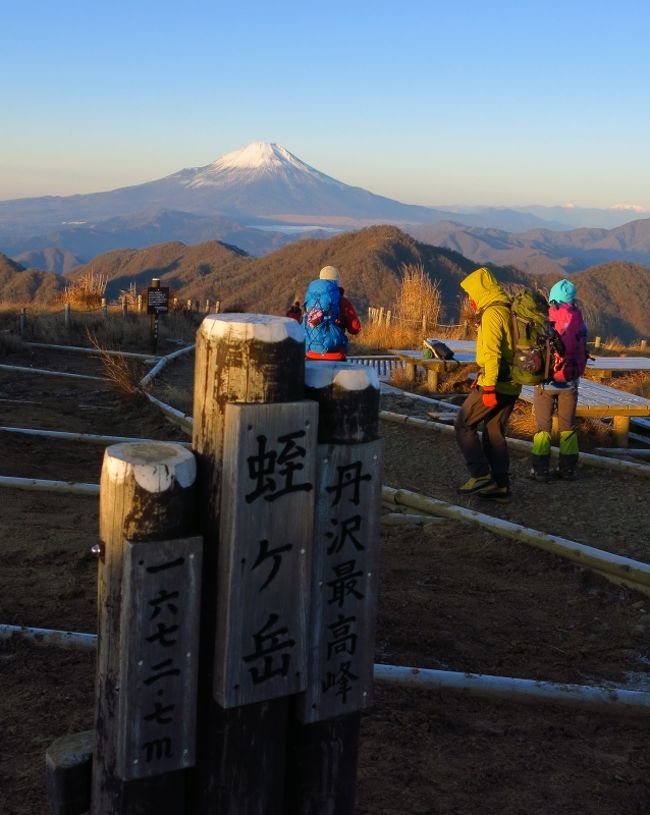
[520,377,650,447]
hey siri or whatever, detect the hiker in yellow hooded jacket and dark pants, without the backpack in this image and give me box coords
[455,266,521,502]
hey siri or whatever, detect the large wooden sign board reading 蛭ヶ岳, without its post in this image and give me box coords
[215,402,318,707]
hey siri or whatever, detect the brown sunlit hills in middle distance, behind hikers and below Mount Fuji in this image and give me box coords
[55,226,650,342]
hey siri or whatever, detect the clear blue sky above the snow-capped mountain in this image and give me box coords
[0,0,650,210]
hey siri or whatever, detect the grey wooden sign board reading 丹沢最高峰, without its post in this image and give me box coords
[297,440,382,722]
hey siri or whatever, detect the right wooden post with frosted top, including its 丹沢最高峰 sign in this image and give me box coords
[286,362,382,815]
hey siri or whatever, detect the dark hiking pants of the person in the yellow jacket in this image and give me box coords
[454,388,517,487]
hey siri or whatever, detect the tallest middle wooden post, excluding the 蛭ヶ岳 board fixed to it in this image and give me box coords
[188,314,305,815]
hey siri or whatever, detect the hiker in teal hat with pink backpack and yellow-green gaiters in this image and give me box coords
[530,279,588,483]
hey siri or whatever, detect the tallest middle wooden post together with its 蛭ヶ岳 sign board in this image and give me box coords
[188,314,308,815]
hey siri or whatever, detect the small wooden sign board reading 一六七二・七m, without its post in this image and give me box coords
[116,537,203,781]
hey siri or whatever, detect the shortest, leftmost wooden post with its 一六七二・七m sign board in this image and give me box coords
[91,442,202,815]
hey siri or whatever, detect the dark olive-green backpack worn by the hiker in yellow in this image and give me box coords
[510,288,564,385]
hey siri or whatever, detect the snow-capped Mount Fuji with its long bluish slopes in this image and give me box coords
[0,142,440,236]
